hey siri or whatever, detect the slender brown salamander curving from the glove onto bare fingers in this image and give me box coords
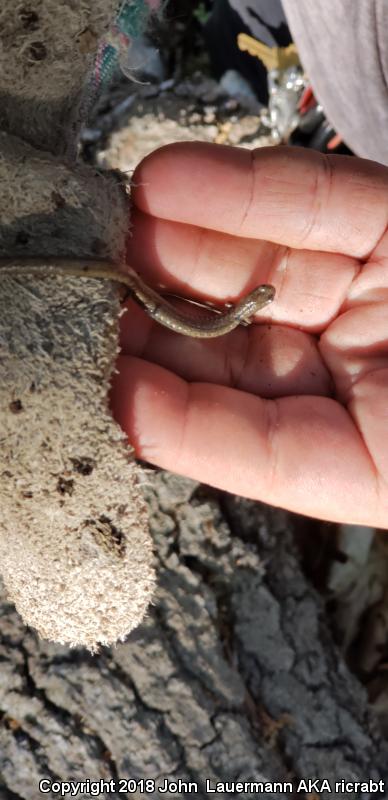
[0,256,275,339]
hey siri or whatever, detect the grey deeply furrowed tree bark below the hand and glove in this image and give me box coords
[0,473,388,800]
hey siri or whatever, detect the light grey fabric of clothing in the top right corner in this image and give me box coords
[283,0,388,165]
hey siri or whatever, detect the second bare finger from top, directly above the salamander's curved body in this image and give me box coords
[127,211,360,333]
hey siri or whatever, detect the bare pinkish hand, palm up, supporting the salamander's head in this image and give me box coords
[112,143,388,527]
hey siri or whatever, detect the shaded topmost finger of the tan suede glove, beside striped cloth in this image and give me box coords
[0,0,118,154]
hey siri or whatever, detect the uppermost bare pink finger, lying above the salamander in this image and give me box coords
[132,142,388,258]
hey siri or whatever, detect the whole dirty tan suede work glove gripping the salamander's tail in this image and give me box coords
[0,0,154,649]
